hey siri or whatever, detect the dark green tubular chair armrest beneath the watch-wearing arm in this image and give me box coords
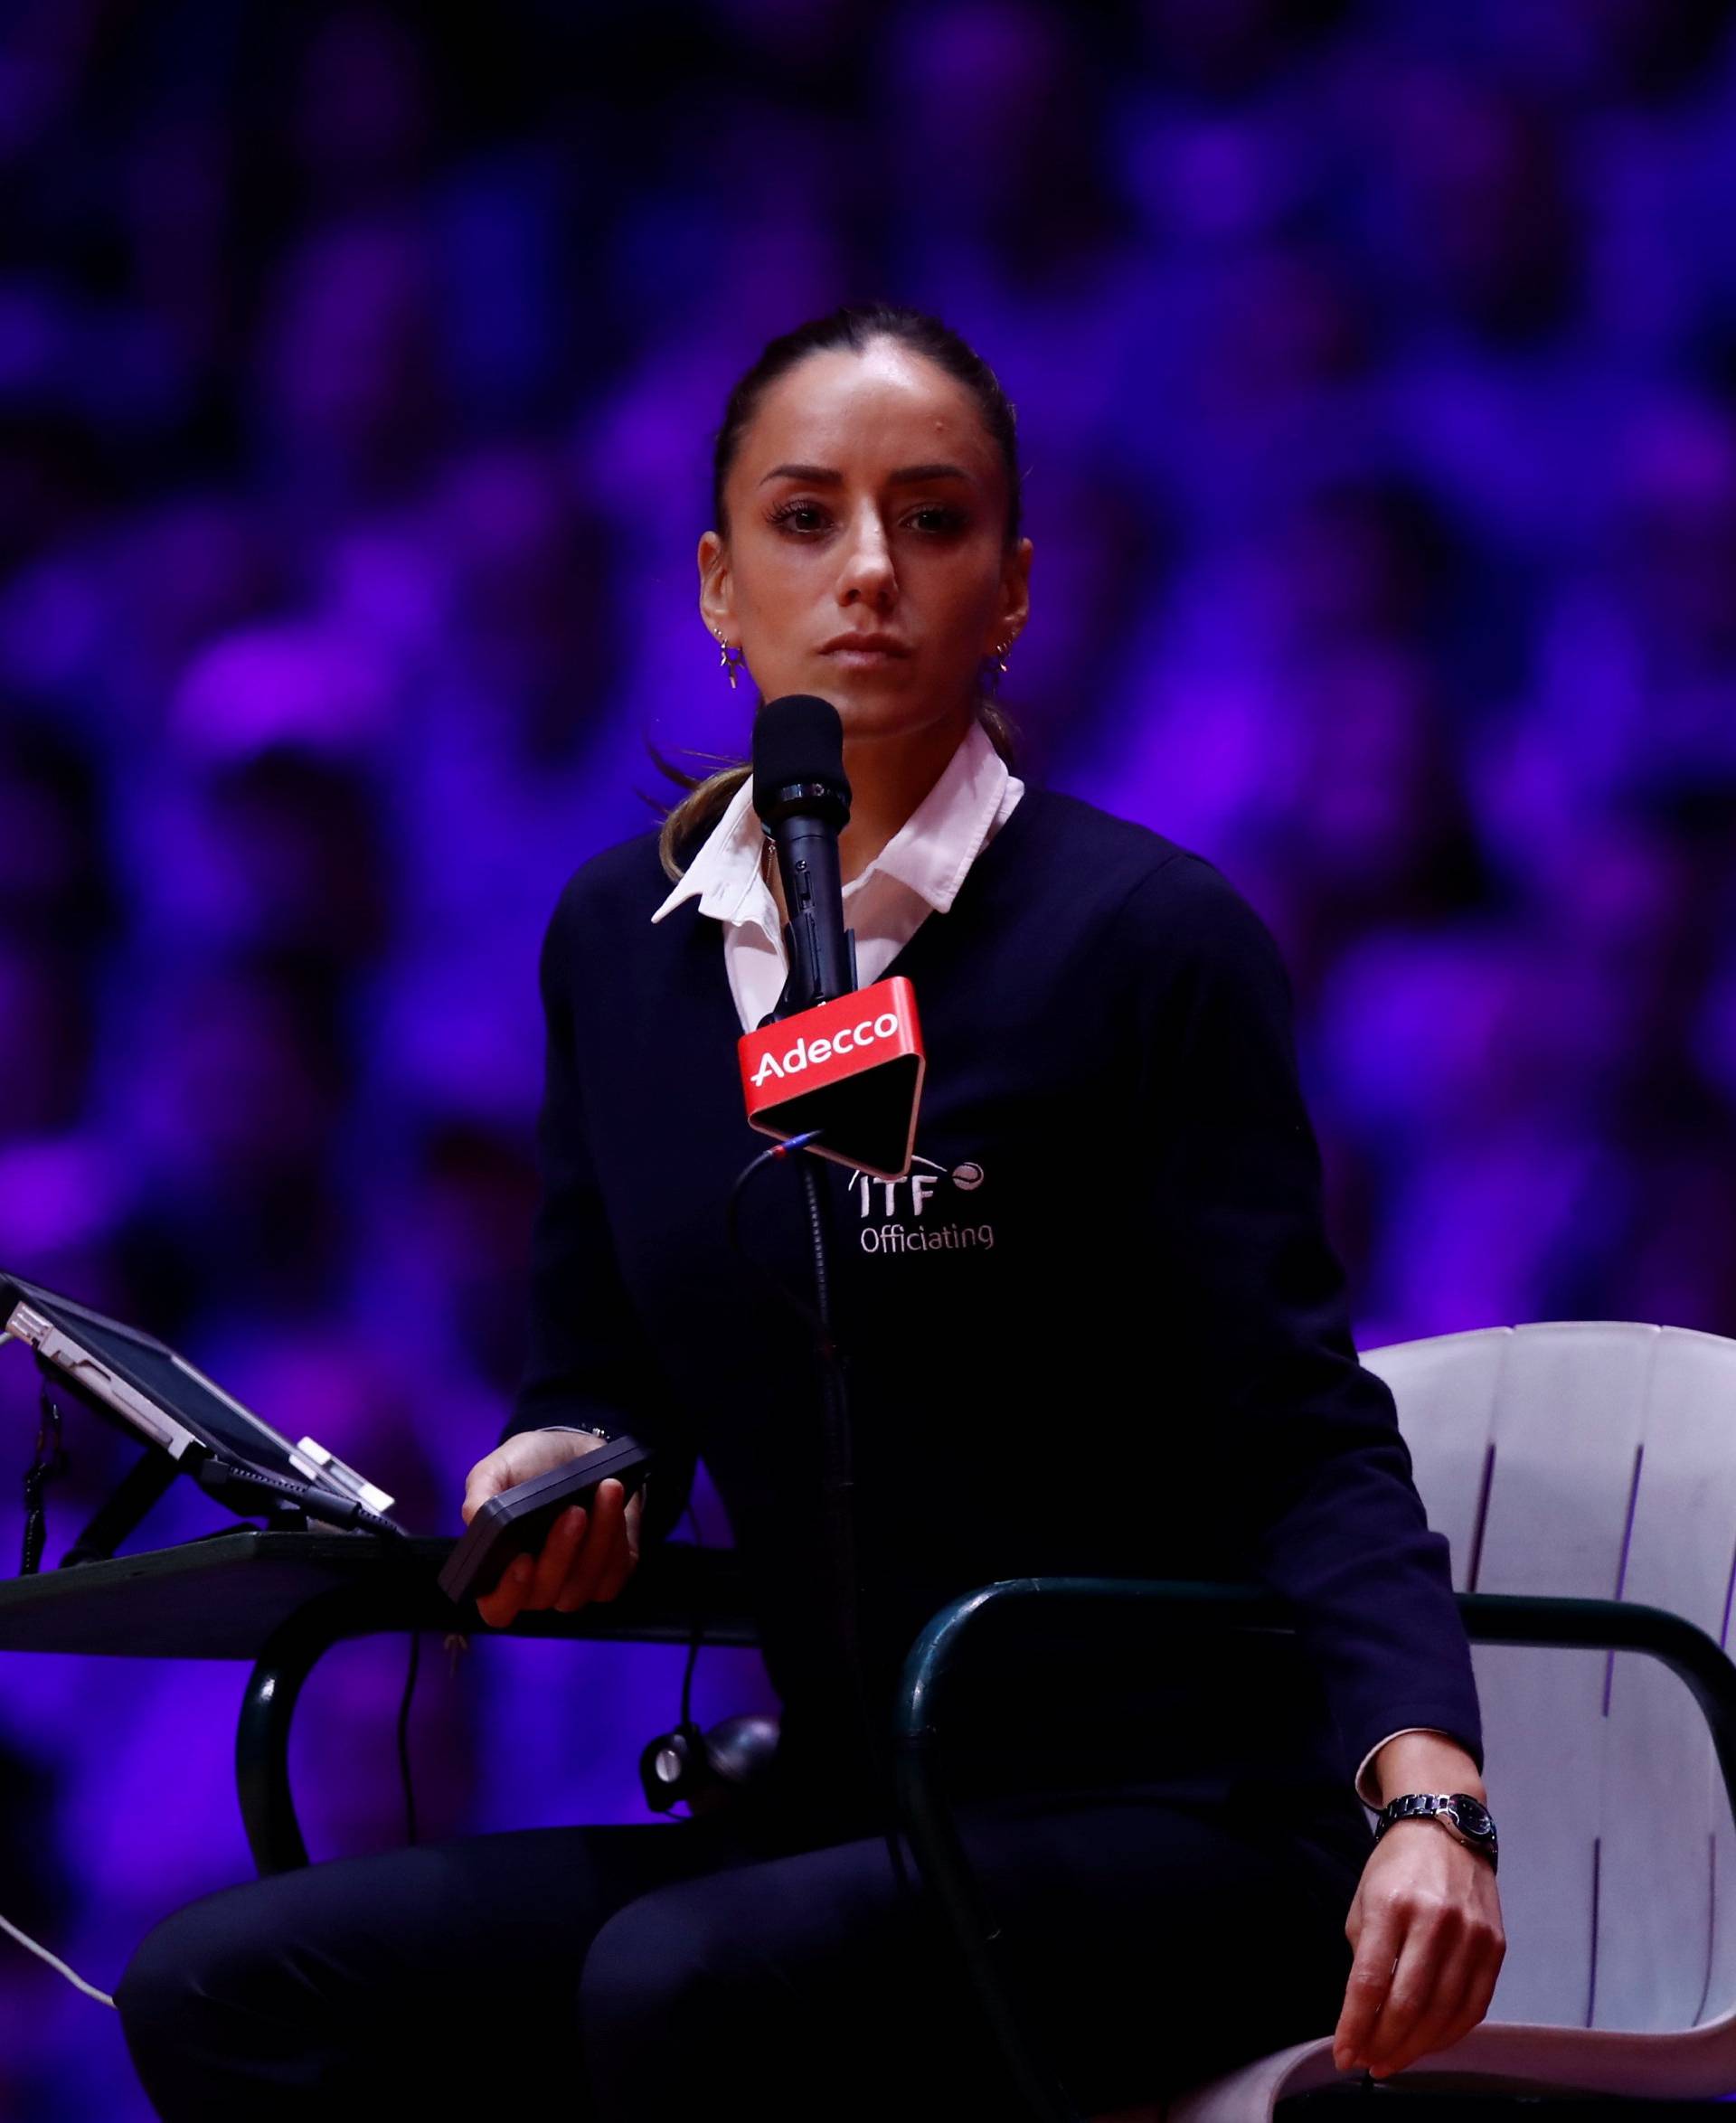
[893,1578,1736,2123]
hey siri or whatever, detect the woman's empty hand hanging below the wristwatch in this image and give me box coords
[1333,1819,1507,2079]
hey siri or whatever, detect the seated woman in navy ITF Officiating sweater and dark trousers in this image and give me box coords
[118,310,1500,2123]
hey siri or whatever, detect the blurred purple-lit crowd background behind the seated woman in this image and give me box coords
[0,0,1736,2123]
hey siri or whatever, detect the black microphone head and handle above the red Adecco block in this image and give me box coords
[753,692,855,1017]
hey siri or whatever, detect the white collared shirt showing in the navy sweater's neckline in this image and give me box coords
[652,722,1025,1032]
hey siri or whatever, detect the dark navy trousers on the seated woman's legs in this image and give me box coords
[117,1792,1367,2123]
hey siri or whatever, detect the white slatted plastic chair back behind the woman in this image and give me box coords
[1363,1323,1736,2030]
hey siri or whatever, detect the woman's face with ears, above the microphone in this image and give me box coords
[698,340,1032,743]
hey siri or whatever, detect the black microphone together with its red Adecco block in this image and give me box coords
[736,692,928,1180]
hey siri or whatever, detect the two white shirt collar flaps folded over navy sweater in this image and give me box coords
[652,722,1008,934]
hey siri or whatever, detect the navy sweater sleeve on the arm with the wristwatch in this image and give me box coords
[1125,855,1481,1777]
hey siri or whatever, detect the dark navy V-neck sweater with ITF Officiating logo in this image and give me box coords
[496,789,1479,1826]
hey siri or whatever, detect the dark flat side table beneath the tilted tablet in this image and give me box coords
[0,1526,753,1658]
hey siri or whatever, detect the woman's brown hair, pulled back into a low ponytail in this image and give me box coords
[654,304,1019,877]
